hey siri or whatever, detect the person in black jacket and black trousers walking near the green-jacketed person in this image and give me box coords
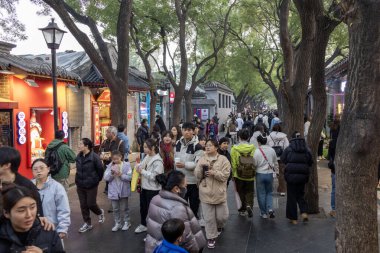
[75,138,105,233]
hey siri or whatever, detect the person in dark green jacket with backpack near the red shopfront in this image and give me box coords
[45,130,76,192]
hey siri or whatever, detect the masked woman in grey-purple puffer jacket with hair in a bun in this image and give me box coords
[145,170,206,253]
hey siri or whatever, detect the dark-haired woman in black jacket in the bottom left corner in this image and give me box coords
[0,185,65,253]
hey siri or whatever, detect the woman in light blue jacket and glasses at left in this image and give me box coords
[32,158,71,239]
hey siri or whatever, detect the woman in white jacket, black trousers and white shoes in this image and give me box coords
[135,139,164,234]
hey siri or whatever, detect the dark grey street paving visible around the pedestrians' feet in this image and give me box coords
[65,161,335,253]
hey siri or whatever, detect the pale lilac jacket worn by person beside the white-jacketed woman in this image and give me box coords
[104,162,132,200]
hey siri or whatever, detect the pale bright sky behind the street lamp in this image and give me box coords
[11,0,83,55]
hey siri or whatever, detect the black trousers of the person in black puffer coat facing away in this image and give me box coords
[286,183,307,220]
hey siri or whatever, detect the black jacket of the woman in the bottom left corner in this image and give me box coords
[0,218,65,253]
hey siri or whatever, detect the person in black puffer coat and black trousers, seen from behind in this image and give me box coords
[281,132,313,224]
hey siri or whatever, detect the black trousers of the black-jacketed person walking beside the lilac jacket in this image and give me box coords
[77,186,102,225]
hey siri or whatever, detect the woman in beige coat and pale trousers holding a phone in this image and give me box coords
[194,140,231,249]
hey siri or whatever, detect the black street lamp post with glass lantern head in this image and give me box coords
[39,18,66,133]
